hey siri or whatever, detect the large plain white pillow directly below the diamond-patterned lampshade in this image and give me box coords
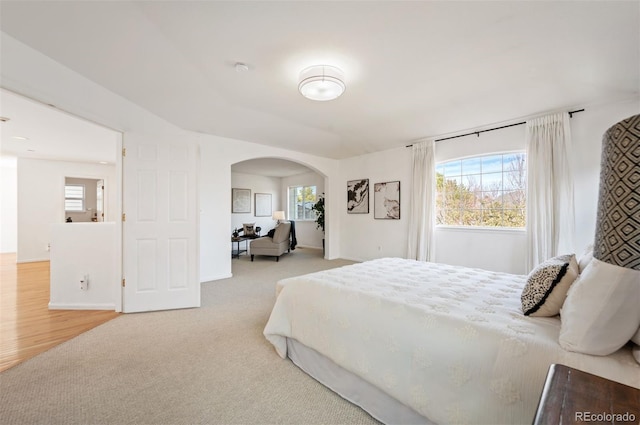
[560,258,640,356]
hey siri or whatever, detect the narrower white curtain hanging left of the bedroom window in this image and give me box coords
[407,140,436,261]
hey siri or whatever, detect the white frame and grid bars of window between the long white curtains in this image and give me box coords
[434,150,527,227]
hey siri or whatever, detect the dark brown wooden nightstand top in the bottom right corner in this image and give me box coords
[533,364,640,425]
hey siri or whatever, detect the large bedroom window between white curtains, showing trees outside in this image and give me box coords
[436,153,527,228]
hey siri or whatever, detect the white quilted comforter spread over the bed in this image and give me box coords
[264,258,640,424]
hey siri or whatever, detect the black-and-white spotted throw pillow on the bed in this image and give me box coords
[520,254,578,317]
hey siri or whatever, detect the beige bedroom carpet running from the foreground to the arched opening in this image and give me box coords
[0,248,377,424]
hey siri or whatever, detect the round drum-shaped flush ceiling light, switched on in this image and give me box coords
[298,65,346,101]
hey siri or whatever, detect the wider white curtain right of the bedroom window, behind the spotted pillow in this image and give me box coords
[526,112,576,270]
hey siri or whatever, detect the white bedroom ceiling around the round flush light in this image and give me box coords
[0,1,640,158]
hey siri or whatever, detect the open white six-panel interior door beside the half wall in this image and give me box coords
[122,134,200,313]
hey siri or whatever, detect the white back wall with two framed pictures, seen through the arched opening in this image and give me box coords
[229,173,281,236]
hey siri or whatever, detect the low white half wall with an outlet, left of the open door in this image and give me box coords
[49,222,120,310]
